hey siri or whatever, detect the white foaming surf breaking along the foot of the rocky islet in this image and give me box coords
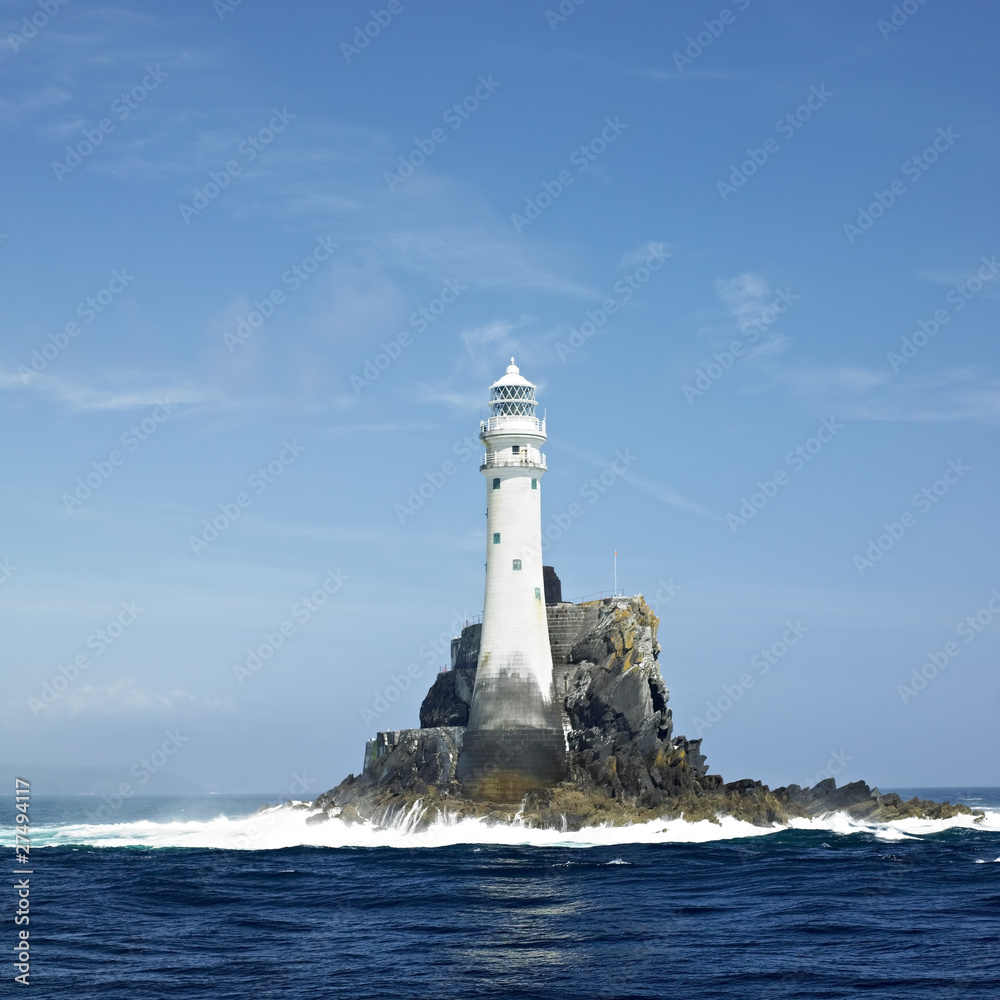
[7,803,1000,851]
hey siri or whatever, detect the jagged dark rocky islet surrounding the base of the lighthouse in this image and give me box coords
[314,596,981,829]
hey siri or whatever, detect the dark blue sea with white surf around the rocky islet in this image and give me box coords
[0,788,1000,1000]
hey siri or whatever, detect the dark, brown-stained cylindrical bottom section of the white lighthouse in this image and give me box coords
[456,726,567,803]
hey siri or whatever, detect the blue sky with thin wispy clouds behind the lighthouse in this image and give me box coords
[0,0,1000,793]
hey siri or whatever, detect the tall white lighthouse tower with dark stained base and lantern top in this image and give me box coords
[457,358,566,802]
